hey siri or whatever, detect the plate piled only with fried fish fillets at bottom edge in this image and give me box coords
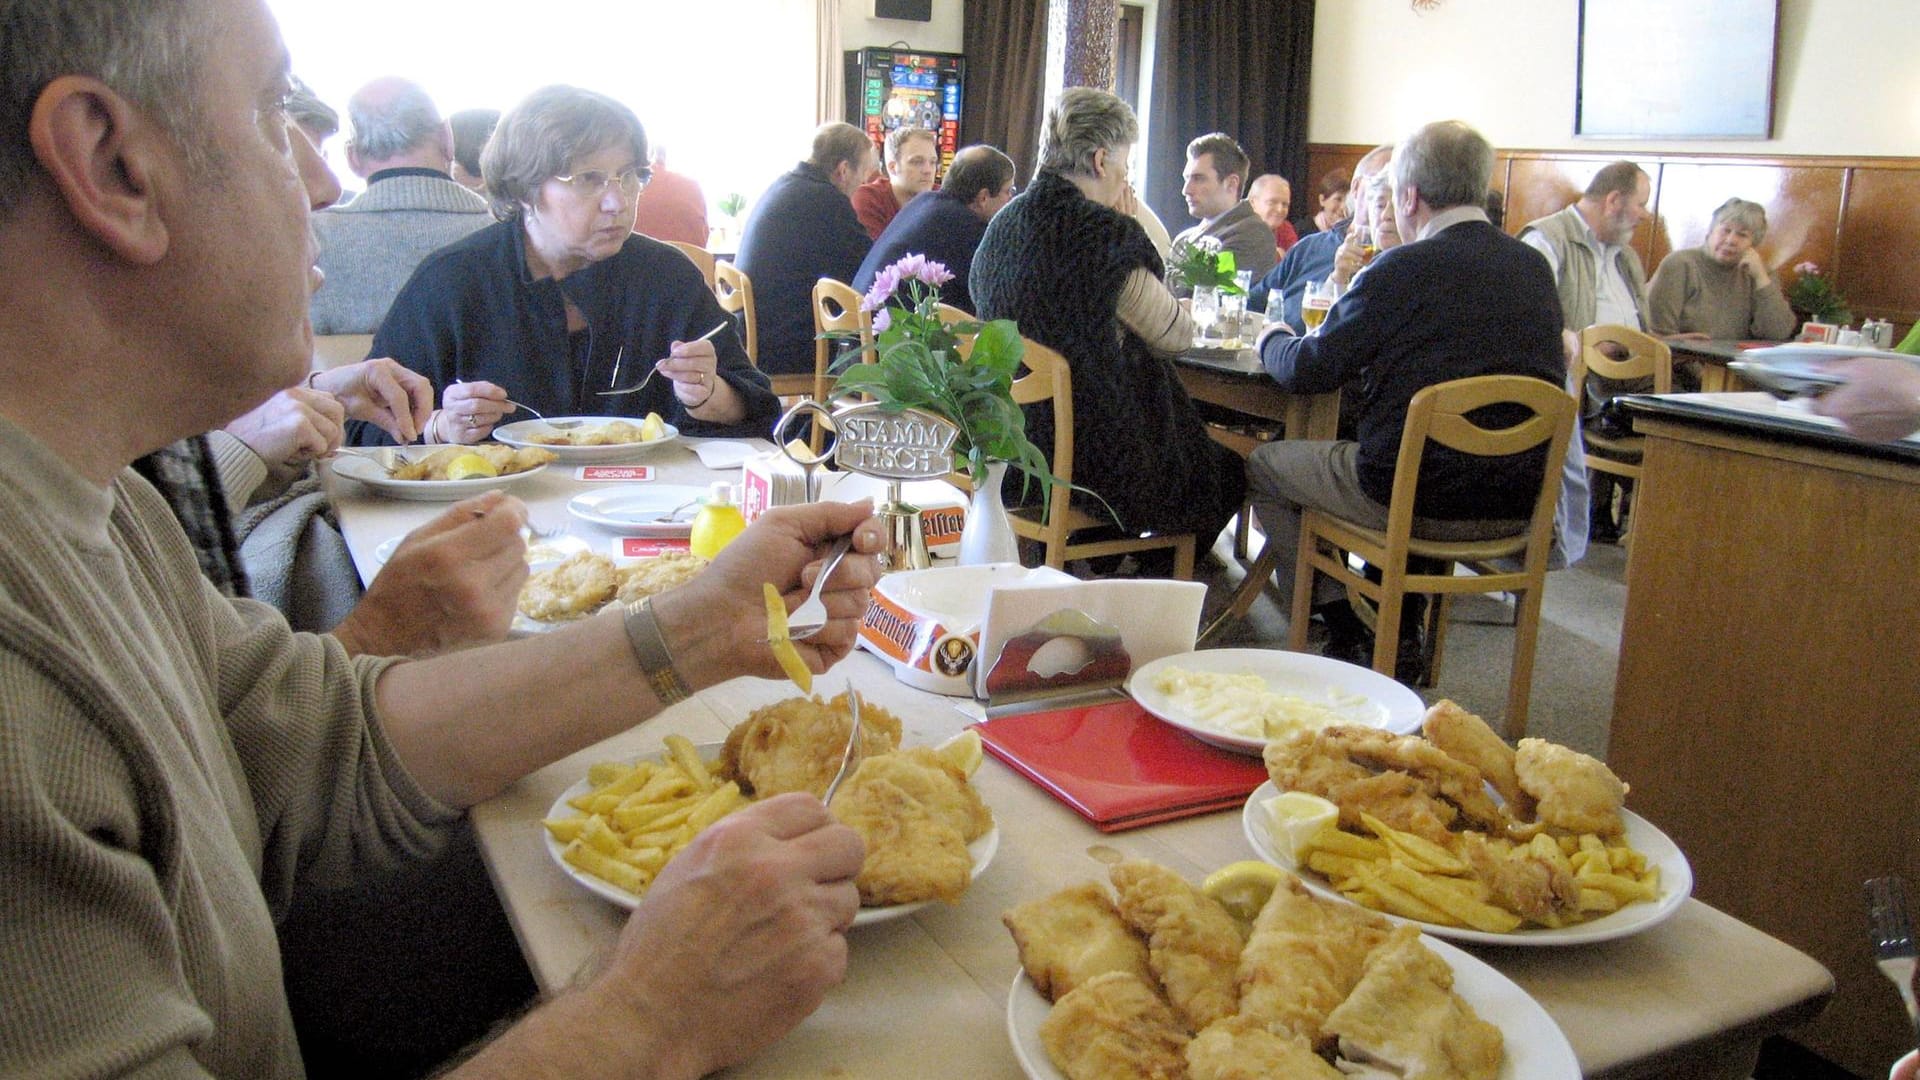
[1002,859,1580,1080]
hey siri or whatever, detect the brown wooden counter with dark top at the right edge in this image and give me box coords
[1609,394,1920,1076]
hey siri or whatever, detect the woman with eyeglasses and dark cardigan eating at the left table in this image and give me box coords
[351,86,780,442]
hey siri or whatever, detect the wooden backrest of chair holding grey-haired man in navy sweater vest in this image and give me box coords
[1386,375,1578,573]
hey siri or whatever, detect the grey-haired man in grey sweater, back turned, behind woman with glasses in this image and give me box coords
[313,77,493,334]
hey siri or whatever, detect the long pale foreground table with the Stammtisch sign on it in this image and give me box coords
[330,442,1832,1080]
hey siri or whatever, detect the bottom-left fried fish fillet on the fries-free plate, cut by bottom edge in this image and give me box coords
[1041,970,1187,1080]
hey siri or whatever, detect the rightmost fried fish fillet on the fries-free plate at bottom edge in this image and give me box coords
[1327,914,1503,1080]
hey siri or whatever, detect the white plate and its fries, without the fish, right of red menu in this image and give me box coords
[1240,780,1693,945]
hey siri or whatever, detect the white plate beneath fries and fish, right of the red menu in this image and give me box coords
[1240,780,1693,945]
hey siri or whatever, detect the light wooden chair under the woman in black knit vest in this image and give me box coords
[1008,338,1194,580]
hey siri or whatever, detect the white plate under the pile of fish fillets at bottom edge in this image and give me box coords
[1006,938,1580,1080]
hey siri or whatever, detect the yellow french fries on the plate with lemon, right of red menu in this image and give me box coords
[1304,815,1661,934]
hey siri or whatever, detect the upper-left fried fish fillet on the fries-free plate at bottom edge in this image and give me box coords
[1000,882,1154,1001]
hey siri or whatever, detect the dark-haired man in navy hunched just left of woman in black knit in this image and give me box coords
[852,146,1014,315]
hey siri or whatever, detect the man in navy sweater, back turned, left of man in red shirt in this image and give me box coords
[733,123,874,375]
